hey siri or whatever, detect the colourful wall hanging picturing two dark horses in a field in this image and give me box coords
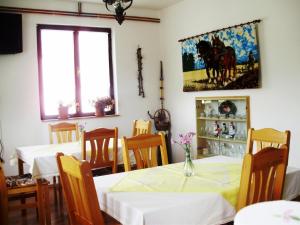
[181,24,260,92]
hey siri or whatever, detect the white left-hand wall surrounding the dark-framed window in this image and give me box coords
[0,0,160,175]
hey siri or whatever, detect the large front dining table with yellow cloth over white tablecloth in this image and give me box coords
[94,156,300,225]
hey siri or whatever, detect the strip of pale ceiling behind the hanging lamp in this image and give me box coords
[65,0,182,10]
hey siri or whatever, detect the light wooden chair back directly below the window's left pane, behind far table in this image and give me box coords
[48,122,79,144]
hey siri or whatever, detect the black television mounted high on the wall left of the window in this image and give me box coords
[0,13,23,54]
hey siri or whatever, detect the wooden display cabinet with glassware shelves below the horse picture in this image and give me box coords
[196,96,250,158]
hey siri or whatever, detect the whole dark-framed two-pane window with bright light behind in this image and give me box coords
[37,25,114,120]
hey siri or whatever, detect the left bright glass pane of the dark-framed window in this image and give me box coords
[41,30,75,115]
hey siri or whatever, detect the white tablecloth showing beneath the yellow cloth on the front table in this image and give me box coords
[94,156,300,225]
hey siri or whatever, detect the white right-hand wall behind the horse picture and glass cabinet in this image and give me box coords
[161,0,300,167]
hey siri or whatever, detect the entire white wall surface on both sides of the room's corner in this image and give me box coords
[0,0,300,174]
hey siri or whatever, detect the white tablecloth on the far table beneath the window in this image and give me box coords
[16,139,123,178]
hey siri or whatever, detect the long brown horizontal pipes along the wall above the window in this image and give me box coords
[0,6,160,23]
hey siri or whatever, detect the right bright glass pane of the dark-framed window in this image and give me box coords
[79,31,110,113]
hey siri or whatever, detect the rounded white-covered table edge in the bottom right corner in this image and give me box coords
[234,201,300,225]
